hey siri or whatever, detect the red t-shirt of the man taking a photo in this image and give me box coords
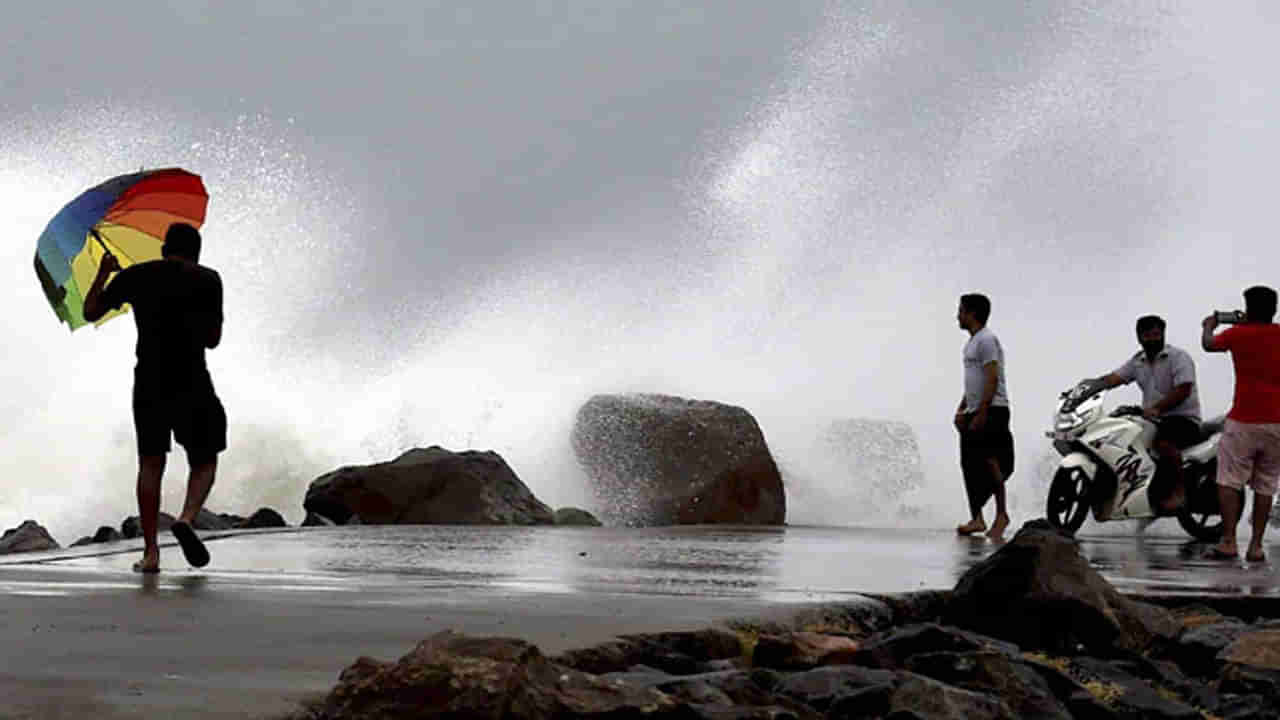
[1213,323,1280,423]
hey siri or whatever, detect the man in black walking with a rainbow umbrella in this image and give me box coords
[84,223,227,573]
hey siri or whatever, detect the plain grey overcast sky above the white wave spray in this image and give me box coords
[0,0,822,297]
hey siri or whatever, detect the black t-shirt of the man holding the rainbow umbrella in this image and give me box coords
[102,260,223,379]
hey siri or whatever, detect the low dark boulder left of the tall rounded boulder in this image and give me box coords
[302,446,554,525]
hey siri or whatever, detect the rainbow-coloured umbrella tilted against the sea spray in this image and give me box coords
[36,168,209,331]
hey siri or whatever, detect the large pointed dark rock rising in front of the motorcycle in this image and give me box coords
[945,520,1179,655]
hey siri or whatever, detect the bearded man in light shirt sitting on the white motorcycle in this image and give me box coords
[1089,315,1201,514]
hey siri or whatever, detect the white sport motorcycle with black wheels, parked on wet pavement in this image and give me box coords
[1044,380,1224,542]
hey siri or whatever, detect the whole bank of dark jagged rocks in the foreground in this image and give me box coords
[288,521,1280,720]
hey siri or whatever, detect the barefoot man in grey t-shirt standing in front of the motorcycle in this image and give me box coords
[955,293,1014,538]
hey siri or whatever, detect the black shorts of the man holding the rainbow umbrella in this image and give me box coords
[133,372,227,462]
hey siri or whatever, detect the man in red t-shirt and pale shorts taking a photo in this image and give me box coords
[1201,286,1280,562]
